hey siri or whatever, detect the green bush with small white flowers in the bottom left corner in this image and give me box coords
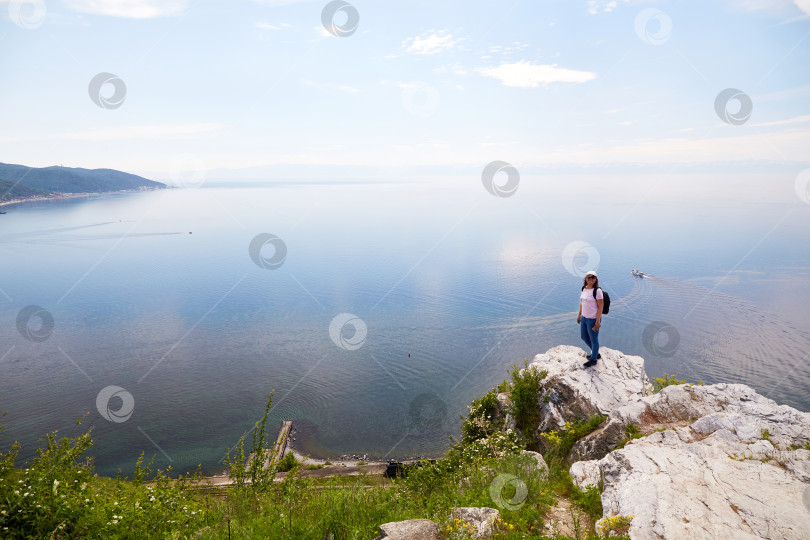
[0,420,206,539]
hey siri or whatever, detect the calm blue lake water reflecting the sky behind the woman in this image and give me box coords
[0,175,810,474]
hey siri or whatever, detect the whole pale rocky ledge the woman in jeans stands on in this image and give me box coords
[524,346,810,539]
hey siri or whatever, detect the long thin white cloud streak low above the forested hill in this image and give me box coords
[0,122,225,143]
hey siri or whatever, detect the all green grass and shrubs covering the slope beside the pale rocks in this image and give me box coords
[0,376,626,540]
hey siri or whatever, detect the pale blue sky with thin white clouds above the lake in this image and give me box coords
[0,0,810,179]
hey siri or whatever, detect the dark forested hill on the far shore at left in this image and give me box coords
[0,163,166,201]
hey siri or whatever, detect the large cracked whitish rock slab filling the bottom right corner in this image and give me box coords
[596,427,810,540]
